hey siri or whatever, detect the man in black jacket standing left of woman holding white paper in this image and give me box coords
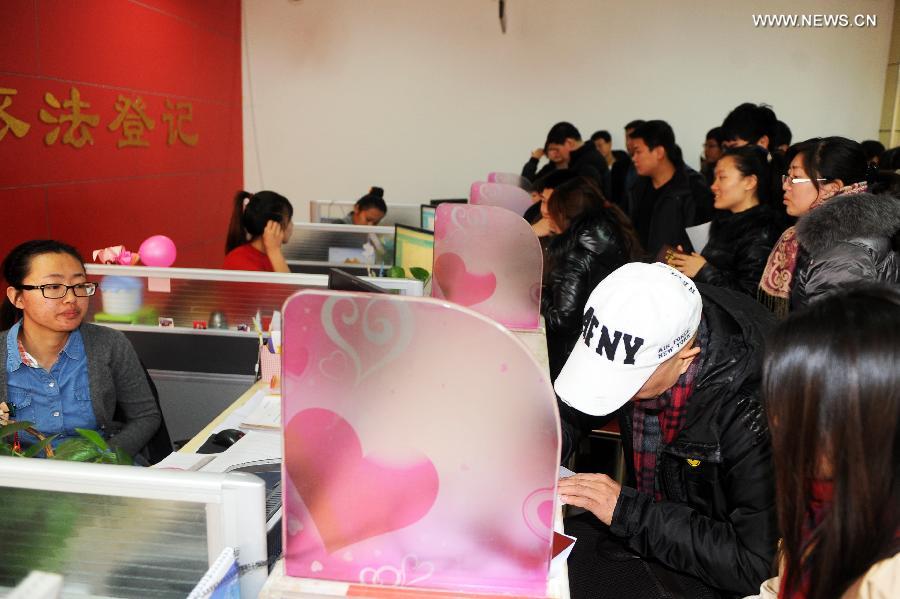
[628,121,713,256]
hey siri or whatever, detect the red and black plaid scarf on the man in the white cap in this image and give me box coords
[632,319,708,501]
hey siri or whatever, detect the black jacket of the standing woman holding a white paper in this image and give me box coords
[694,206,784,297]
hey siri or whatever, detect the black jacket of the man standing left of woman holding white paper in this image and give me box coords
[628,167,713,256]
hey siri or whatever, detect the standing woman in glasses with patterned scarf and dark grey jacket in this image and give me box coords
[759,137,900,316]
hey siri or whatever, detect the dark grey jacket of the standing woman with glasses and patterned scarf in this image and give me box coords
[790,193,900,311]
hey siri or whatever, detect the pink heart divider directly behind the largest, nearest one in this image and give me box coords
[431,204,543,329]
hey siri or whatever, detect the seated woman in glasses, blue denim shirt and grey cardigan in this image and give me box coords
[0,240,161,456]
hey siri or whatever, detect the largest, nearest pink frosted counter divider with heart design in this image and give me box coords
[282,290,560,596]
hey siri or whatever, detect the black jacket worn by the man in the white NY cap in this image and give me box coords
[563,283,778,597]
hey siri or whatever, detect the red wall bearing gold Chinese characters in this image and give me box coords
[0,0,243,268]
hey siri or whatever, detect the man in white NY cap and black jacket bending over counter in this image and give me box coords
[556,263,778,599]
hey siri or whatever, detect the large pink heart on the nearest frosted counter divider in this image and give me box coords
[285,408,438,553]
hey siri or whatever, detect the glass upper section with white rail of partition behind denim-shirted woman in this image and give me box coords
[85,264,422,334]
